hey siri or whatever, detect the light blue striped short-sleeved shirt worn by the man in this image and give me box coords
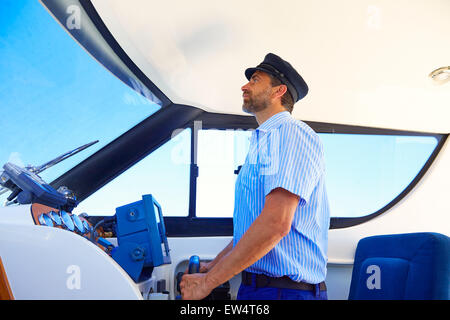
[233,111,330,283]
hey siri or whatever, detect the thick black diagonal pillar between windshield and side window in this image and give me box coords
[51,104,203,201]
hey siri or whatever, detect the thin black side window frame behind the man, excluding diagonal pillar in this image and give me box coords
[165,112,448,237]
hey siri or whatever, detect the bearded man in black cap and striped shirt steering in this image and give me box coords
[180,53,329,300]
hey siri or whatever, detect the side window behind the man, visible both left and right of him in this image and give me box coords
[196,130,438,217]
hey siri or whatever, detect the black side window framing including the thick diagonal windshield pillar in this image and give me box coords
[51,109,448,237]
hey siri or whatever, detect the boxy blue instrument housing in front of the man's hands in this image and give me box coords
[111,195,171,282]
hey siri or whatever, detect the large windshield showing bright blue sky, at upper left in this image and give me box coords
[0,0,160,203]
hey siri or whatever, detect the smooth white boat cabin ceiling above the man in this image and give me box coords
[92,0,450,133]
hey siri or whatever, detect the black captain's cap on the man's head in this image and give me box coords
[245,53,308,103]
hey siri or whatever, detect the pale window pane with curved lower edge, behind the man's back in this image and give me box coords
[319,133,438,218]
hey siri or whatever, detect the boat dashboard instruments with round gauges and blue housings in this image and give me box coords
[0,162,171,282]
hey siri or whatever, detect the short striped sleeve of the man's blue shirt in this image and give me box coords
[260,124,324,203]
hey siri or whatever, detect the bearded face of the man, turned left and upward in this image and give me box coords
[241,70,272,114]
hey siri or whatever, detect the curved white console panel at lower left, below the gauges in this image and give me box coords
[0,223,142,300]
